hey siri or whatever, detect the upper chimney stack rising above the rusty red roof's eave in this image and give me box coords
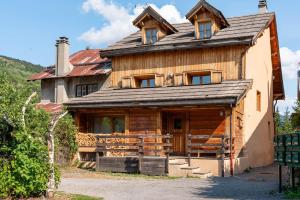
[55,37,73,76]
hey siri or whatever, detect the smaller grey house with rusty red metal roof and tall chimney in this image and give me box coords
[28,37,111,112]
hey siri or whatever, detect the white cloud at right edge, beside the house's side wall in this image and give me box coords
[280,47,300,80]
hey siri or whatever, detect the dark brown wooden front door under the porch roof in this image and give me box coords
[168,113,186,155]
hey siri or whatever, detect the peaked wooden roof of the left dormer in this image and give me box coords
[132,6,178,33]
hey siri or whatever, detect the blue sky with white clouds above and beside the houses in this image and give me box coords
[0,0,300,113]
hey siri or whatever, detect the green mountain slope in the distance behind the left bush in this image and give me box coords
[0,55,43,84]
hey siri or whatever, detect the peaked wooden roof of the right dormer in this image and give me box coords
[185,0,229,28]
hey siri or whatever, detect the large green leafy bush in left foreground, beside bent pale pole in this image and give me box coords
[0,73,49,198]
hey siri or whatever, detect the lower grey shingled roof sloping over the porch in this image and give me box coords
[66,80,252,109]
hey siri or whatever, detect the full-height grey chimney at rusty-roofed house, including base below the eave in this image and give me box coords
[55,37,74,104]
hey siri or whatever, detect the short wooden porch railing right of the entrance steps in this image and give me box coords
[187,134,234,176]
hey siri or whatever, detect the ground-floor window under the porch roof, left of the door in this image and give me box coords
[93,116,125,134]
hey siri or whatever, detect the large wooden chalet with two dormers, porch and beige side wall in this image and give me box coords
[29,0,284,176]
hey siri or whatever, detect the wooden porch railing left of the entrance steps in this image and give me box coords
[96,134,172,172]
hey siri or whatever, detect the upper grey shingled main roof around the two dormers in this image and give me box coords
[101,13,275,57]
